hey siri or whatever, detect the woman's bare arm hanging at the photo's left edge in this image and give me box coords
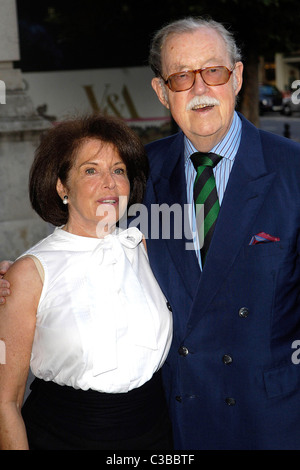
[0,258,42,450]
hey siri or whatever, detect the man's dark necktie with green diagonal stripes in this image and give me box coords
[191,152,222,265]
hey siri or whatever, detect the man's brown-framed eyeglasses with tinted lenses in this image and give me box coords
[163,65,233,92]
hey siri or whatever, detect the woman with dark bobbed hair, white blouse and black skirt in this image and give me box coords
[0,115,172,450]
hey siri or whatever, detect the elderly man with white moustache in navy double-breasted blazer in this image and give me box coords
[0,18,300,450]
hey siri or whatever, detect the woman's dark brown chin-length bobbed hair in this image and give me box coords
[29,114,148,226]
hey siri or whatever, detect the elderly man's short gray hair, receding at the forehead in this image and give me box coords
[149,17,242,77]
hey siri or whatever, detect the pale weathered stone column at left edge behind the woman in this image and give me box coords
[0,0,50,260]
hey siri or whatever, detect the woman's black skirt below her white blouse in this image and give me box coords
[22,371,173,450]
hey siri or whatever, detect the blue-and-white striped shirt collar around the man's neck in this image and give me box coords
[184,111,242,164]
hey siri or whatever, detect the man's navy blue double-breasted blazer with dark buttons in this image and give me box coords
[145,112,300,450]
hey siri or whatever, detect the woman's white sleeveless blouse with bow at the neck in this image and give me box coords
[22,227,172,393]
